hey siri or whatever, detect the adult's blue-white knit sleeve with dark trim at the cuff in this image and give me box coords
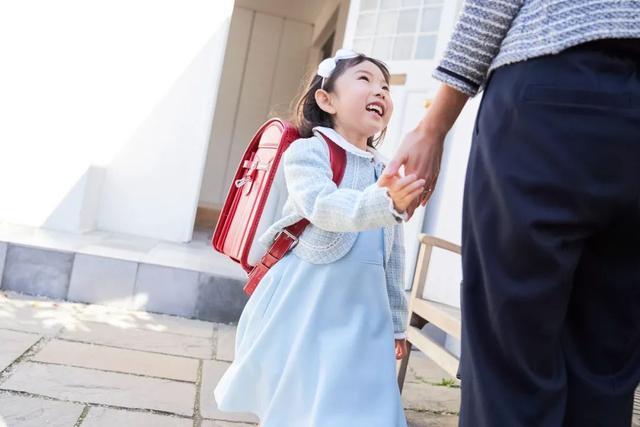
[433,0,524,96]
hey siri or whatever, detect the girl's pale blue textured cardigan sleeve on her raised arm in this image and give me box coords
[284,138,402,232]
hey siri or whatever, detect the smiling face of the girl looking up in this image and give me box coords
[316,61,393,148]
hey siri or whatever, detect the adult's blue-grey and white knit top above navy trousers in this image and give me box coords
[433,0,640,96]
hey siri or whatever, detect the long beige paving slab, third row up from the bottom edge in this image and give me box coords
[31,335,199,383]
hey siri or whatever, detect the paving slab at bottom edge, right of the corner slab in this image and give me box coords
[82,406,193,427]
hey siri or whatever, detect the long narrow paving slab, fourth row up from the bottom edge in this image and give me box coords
[60,322,213,359]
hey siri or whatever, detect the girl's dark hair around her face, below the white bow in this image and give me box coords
[293,54,391,148]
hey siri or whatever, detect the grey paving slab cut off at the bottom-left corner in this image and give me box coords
[0,392,84,427]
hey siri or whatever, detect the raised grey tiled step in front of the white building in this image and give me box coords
[0,223,247,323]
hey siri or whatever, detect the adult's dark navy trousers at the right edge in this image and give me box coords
[460,40,640,427]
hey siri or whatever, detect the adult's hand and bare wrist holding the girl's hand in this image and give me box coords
[384,84,469,216]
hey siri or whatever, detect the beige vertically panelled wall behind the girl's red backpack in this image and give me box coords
[200,7,313,207]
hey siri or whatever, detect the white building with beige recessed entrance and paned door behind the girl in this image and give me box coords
[0,0,479,318]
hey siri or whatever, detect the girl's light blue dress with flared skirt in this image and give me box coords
[214,163,407,427]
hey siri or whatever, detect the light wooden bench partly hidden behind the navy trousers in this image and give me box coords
[397,234,461,392]
